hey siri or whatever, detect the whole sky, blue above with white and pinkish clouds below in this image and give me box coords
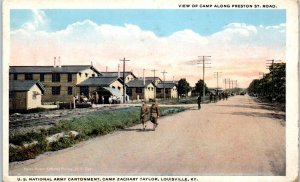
[10,9,286,88]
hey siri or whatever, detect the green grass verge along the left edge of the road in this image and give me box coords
[9,107,185,162]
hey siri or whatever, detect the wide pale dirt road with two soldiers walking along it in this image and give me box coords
[10,96,285,176]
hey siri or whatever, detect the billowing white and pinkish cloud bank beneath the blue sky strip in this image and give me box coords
[10,20,285,87]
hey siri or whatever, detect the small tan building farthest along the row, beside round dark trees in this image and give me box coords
[156,81,178,98]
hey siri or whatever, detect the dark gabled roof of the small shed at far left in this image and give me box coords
[9,80,45,92]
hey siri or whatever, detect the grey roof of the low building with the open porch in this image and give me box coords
[77,76,118,87]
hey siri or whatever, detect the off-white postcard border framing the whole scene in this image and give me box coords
[2,0,299,181]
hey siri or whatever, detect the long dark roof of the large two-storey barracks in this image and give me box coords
[9,65,101,74]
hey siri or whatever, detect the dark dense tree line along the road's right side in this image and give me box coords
[248,63,286,103]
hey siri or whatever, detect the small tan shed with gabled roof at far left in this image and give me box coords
[9,80,45,110]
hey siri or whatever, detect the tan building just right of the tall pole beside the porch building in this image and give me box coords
[126,80,156,101]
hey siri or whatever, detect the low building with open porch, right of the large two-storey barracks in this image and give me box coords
[77,76,123,104]
